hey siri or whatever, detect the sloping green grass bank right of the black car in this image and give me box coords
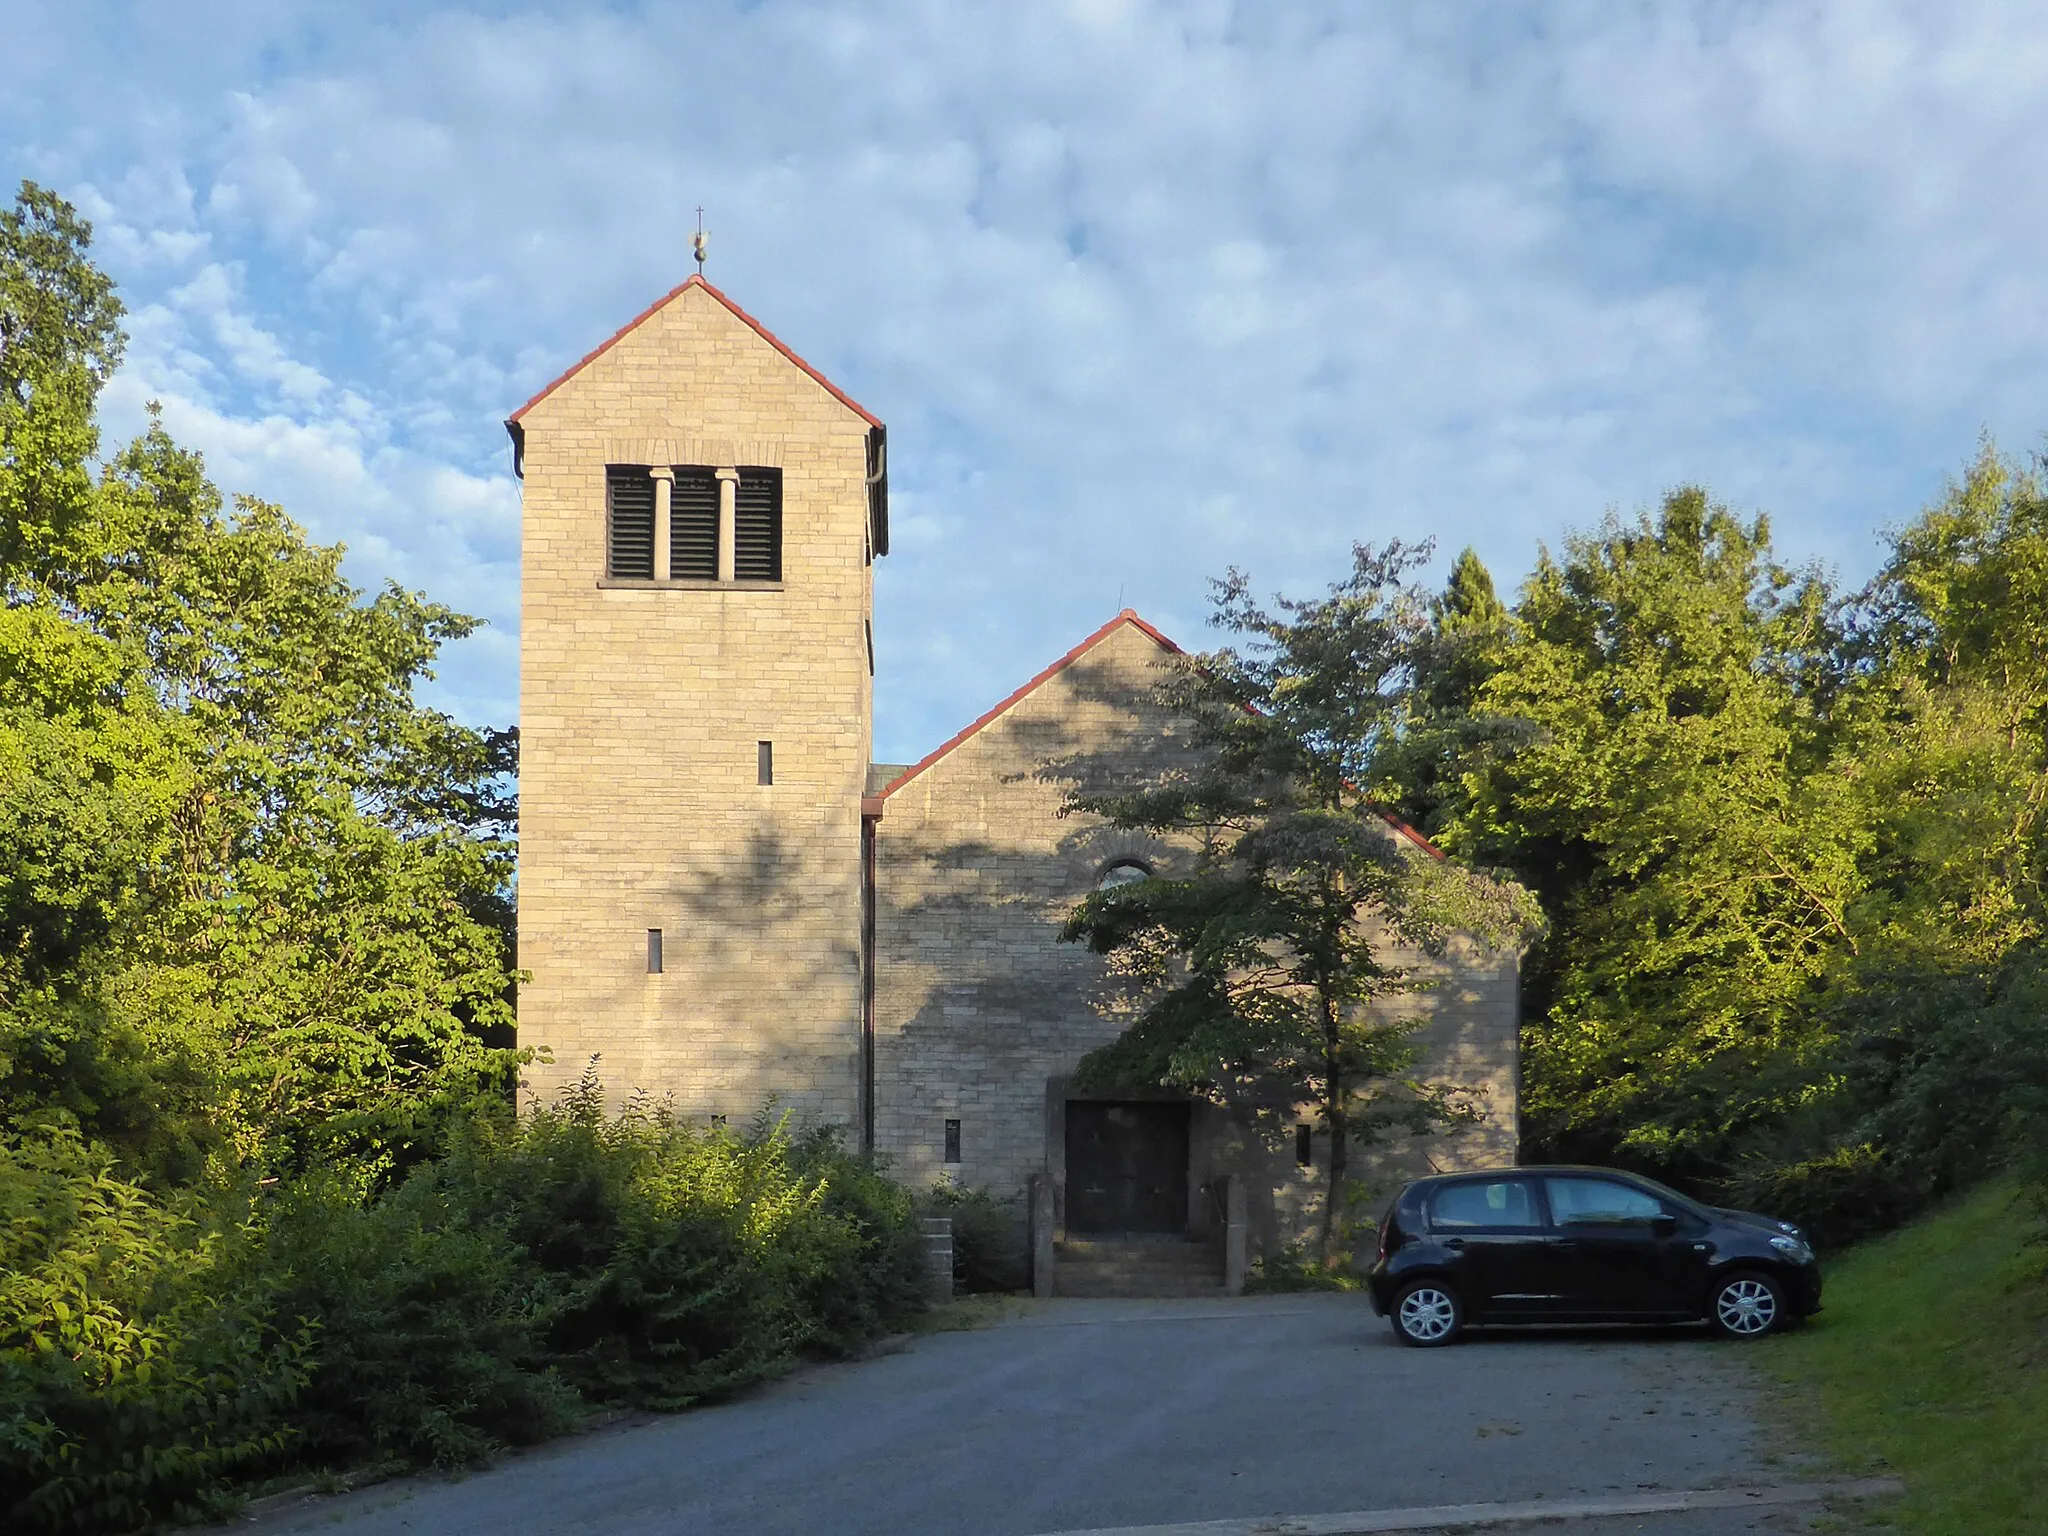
[1772,1184,2048,1536]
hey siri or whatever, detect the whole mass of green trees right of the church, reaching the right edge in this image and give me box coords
[1389,466,2048,1241]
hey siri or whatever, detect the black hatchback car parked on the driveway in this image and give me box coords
[1366,1167,1821,1346]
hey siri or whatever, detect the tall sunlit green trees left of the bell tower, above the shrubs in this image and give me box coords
[0,186,516,1178]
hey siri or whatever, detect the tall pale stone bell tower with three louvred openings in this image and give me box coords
[506,276,889,1124]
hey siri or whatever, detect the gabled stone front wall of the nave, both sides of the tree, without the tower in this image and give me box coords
[877,623,1518,1251]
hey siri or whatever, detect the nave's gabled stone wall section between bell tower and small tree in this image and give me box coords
[874,625,1176,1194]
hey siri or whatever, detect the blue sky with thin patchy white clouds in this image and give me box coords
[12,0,2048,760]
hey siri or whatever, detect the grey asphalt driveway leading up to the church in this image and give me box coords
[258,1294,1867,1536]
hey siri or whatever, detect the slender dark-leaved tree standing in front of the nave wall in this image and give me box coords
[1055,545,1532,1266]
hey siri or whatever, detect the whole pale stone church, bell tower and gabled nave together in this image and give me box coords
[506,276,1518,1290]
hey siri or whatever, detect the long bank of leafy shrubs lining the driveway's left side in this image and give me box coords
[0,1075,924,1532]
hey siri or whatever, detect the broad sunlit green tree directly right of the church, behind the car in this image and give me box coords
[1442,489,1866,1171]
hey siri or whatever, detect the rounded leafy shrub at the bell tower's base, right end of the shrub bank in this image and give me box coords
[448,1073,920,1407]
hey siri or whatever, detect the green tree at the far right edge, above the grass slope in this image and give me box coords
[1737,444,2048,1233]
